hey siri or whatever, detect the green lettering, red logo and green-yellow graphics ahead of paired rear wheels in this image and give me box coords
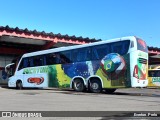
[23,65,71,87]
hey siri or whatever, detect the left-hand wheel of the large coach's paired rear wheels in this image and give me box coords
[73,79,85,92]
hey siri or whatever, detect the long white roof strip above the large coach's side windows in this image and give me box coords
[22,36,136,57]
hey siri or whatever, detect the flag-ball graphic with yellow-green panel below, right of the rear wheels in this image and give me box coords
[97,53,127,88]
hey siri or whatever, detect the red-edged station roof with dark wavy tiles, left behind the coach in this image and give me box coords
[0,25,100,69]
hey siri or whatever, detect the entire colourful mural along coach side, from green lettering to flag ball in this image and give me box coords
[23,53,148,88]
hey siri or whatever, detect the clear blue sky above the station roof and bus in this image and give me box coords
[0,0,160,48]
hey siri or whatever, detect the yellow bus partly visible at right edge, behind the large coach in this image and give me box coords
[148,64,160,87]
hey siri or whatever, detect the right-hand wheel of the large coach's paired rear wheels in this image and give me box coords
[89,78,102,93]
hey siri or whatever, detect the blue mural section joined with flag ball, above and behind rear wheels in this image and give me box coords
[62,53,127,88]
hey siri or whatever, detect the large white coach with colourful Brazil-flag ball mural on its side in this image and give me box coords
[6,36,148,93]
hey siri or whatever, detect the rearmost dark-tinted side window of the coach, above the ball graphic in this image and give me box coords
[111,40,130,55]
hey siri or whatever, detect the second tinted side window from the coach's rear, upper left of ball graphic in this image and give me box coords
[92,45,110,60]
